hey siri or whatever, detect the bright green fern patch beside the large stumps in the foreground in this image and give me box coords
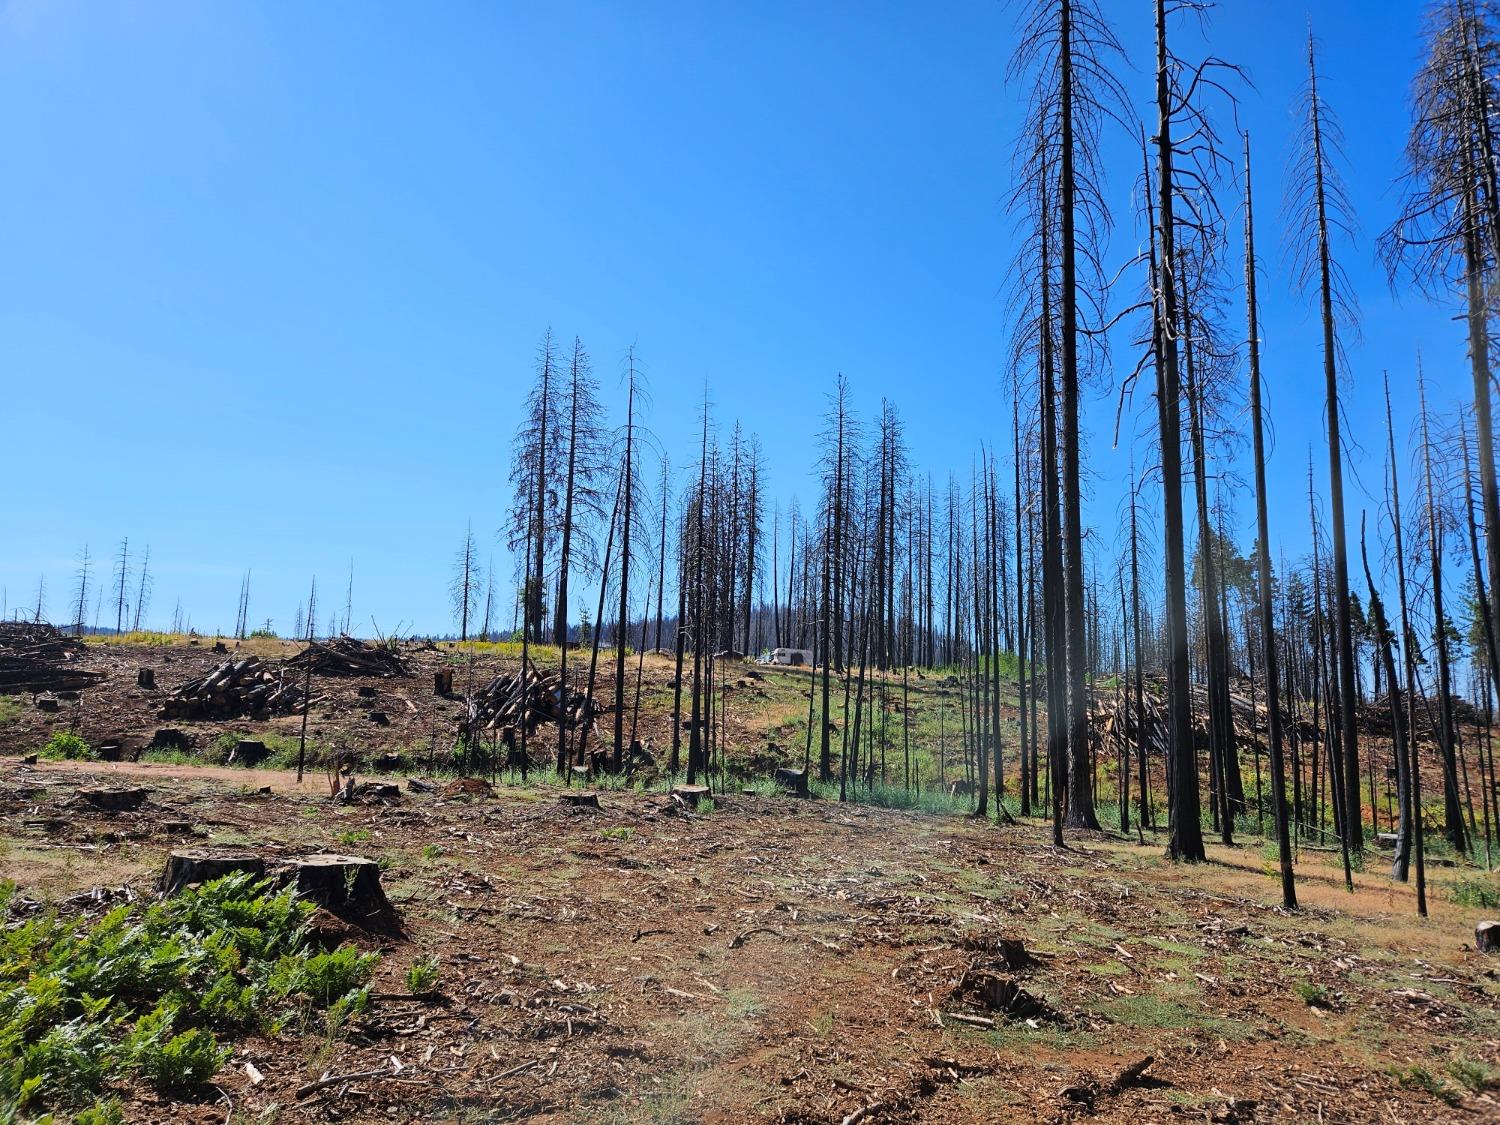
[0,873,377,1122]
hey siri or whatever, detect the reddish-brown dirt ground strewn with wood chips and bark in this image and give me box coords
[0,645,1500,1125]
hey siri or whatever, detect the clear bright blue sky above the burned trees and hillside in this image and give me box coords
[0,0,1469,632]
